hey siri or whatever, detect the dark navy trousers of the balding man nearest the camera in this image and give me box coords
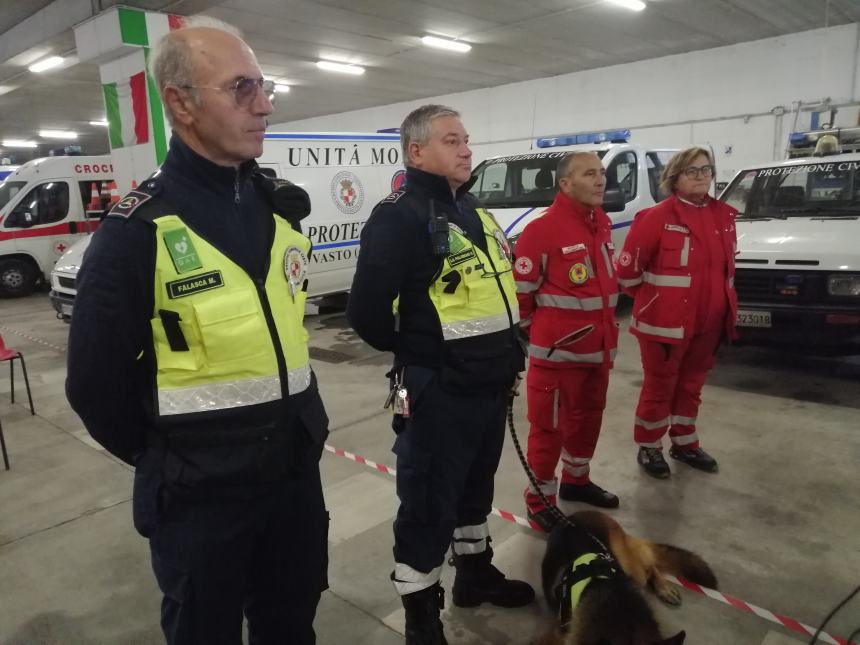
[134,456,328,645]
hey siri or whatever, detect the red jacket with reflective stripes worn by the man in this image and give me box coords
[514,192,618,367]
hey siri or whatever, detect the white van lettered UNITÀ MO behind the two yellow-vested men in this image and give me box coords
[51,132,406,320]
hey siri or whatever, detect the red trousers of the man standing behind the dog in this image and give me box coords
[525,364,609,510]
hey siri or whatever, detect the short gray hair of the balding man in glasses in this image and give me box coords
[149,15,242,125]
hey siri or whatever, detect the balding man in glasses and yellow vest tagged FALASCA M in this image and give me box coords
[67,21,328,645]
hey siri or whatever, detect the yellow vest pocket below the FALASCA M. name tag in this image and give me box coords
[194,291,271,365]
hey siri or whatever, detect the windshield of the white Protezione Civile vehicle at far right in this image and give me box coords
[720,159,860,219]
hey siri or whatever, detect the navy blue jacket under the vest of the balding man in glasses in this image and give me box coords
[66,135,324,484]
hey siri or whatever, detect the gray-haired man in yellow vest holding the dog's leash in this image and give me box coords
[347,105,534,645]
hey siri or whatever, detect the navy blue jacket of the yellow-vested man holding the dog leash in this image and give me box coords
[347,167,523,388]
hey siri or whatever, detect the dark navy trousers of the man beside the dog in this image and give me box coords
[393,366,508,573]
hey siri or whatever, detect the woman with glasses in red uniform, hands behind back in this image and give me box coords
[618,147,737,479]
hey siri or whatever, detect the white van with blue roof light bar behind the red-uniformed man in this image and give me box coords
[470,130,677,249]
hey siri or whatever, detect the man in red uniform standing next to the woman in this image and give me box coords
[514,152,618,530]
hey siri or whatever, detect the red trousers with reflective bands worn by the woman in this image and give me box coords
[633,331,722,449]
